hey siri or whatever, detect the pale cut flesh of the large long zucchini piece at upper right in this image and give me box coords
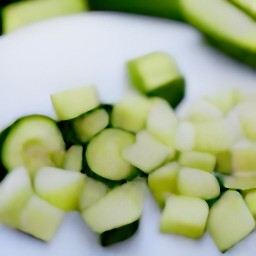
[180,0,256,53]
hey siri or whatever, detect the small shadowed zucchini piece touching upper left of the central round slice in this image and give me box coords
[72,108,109,144]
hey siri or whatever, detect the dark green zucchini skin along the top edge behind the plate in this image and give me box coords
[88,0,183,20]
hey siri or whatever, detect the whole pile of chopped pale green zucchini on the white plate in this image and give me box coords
[0,52,256,252]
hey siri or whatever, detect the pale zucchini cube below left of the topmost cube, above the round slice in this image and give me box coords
[111,95,152,132]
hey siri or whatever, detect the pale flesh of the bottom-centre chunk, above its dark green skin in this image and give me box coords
[82,181,144,234]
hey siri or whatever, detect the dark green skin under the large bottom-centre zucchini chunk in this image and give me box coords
[99,220,139,247]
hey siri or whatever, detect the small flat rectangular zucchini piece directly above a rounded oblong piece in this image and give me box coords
[178,151,216,172]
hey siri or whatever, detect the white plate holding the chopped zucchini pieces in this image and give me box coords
[0,13,256,256]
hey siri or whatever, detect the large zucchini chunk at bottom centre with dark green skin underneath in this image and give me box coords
[82,180,145,246]
